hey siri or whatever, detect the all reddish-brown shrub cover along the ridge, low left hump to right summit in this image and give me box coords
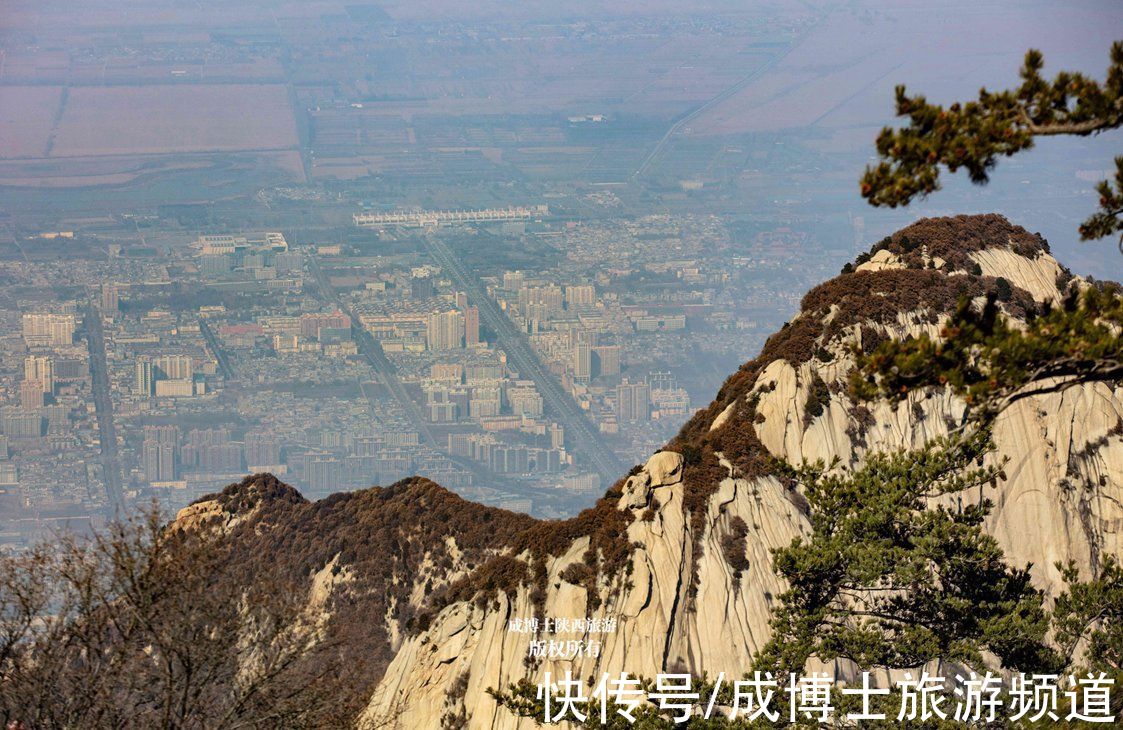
[8,216,1048,717]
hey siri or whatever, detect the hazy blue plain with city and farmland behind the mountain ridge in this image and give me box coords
[0,0,1119,548]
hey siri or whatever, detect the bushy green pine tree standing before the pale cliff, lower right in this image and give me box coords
[757,429,1060,674]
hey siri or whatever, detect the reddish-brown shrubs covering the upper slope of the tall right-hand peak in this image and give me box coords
[666,215,1049,584]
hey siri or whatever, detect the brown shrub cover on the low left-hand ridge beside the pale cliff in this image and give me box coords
[195,474,633,711]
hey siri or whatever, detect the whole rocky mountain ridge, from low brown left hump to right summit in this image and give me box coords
[168,216,1123,728]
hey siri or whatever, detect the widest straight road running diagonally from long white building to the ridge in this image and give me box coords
[422,236,624,486]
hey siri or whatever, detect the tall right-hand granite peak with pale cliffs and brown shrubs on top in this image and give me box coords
[352,216,1123,728]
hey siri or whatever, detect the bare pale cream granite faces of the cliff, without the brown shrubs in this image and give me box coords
[360,219,1123,728]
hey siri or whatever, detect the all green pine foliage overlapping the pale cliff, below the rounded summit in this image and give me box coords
[757,285,1123,672]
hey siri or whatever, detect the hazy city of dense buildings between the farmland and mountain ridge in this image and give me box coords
[0,204,835,544]
